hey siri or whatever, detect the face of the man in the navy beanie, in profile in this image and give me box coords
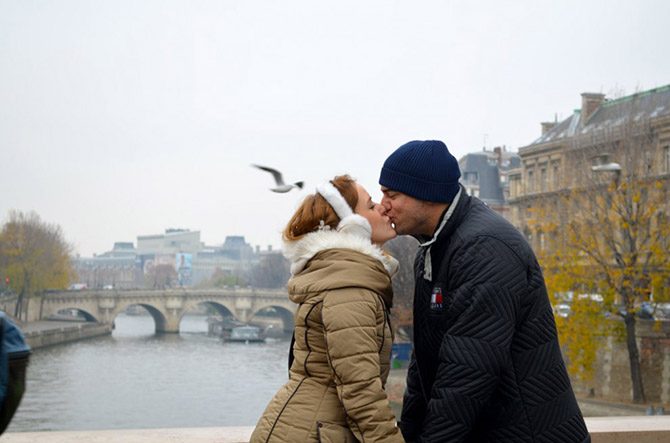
[381,186,435,235]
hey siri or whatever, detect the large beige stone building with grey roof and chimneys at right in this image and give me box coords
[509,85,670,250]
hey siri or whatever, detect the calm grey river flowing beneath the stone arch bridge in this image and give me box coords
[7,314,289,432]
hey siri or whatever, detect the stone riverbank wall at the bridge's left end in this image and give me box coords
[19,320,112,350]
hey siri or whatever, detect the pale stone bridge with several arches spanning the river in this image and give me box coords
[26,288,296,332]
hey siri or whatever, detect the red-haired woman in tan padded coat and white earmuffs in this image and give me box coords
[251,175,403,443]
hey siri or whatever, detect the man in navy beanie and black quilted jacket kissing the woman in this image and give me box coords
[379,141,590,442]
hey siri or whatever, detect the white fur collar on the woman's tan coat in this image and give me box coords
[283,230,398,276]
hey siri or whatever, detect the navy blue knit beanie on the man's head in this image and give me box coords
[379,140,461,203]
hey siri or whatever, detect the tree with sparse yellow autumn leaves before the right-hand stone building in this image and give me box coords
[528,96,670,403]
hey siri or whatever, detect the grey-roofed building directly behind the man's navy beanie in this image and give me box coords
[458,146,520,216]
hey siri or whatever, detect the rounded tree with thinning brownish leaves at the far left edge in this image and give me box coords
[0,211,73,319]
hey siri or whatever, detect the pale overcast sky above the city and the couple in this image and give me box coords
[0,0,670,256]
